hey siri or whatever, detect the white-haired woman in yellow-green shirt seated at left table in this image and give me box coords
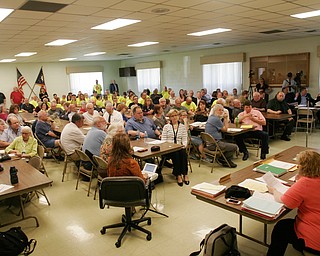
[5,126,38,158]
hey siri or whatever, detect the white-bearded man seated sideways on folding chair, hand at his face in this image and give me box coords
[205,104,238,168]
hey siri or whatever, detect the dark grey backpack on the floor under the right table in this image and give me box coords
[190,224,240,256]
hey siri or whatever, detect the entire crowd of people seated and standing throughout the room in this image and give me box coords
[0,79,320,255]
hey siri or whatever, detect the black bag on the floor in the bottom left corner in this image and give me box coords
[0,227,37,256]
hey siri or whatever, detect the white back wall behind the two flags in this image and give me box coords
[0,61,120,102]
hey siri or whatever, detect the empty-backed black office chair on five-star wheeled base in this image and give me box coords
[99,176,152,248]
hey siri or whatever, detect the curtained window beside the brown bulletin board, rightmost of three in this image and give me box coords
[202,62,242,93]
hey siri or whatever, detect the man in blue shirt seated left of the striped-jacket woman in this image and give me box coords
[126,106,160,139]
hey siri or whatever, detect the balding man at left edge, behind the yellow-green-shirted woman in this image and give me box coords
[0,115,21,148]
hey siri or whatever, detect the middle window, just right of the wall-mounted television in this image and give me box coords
[137,68,160,92]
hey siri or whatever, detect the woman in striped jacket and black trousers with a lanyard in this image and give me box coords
[161,109,190,187]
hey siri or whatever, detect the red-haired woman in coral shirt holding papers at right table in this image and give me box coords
[267,150,320,256]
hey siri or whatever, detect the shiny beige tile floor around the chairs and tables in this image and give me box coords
[0,130,320,256]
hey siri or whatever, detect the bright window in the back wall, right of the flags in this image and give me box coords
[69,72,103,95]
